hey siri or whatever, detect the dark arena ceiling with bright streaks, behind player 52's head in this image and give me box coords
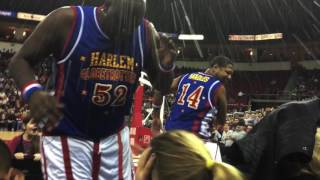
[0,0,320,42]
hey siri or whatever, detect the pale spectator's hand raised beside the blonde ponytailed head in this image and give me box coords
[136,148,156,180]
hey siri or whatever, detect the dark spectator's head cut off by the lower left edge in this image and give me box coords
[0,140,11,179]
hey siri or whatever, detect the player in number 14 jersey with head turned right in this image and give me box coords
[165,56,233,140]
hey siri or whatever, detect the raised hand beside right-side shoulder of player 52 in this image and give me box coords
[158,34,178,69]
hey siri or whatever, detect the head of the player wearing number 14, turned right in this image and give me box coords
[207,56,233,81]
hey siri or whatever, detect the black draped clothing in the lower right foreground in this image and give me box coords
[227,98,320,180]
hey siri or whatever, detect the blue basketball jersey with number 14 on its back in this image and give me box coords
[165,72,222,139]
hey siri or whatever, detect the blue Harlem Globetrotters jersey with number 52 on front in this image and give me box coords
[51,6,150,140]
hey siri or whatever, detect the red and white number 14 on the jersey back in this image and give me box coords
[177,83,204,109]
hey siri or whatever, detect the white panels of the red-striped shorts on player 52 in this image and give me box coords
[41,127,132,180]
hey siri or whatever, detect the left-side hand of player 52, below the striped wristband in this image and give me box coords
[29,91,62,131]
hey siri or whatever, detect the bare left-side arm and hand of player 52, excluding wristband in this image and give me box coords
[9,7,73,130]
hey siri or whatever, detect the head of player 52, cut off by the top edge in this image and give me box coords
[105,0,146,39]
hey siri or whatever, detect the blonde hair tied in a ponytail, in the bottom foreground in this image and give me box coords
[151,131,243,180]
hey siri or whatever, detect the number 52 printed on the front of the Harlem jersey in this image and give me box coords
[91,83,128,107]
